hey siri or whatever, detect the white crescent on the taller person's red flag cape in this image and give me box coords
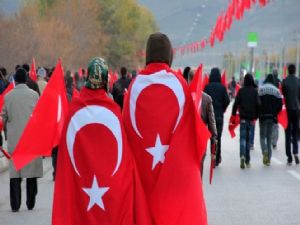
[129,70,185,138]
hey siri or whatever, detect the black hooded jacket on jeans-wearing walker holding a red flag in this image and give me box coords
[232,75,260,120]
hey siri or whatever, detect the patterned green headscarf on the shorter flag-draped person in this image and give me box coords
[85,57,108,89]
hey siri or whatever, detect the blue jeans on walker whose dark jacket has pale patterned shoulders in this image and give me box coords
[259,119,274,159]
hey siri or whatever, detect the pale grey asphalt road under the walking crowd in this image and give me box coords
[0,106,300,225]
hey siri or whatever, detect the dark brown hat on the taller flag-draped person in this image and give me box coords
[146,32,173,66]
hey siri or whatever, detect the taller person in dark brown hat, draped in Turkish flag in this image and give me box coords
[123,33,207,225]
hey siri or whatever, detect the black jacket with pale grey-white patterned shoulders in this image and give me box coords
[258,83,282,122]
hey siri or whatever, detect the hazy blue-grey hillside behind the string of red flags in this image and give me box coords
[139,0,300,67]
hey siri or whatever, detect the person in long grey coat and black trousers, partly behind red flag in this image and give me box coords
[2,68,43,212]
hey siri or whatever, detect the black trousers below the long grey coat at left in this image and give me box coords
[10,178,38,211]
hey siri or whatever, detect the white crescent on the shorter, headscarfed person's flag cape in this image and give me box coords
[66,105,123,176]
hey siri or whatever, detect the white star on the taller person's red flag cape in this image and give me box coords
[146,134,169,170]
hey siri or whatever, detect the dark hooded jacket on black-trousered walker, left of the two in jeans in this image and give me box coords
[204,74,230,118]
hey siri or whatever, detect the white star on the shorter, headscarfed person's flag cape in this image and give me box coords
[82,175,109,211]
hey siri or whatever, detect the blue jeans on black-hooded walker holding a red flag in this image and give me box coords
[240,119,254,163]
